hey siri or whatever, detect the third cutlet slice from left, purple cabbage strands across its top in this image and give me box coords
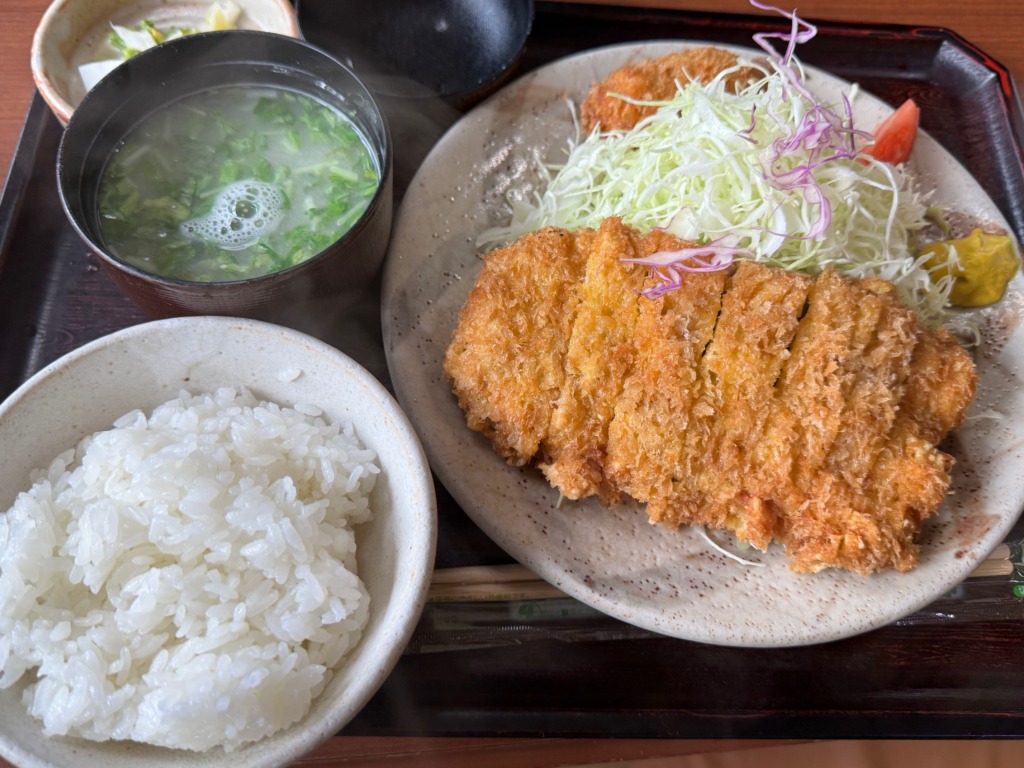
[605,236,728,509]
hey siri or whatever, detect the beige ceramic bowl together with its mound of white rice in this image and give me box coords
[0,316,436,768]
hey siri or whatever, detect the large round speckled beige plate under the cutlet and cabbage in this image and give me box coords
[383,41,1024,646]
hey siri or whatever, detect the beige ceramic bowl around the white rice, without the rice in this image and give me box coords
[0,317,436,768]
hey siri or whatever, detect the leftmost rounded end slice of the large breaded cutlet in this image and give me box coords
[444,227,594,466]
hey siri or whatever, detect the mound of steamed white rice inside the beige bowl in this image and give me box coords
[0,388,379,751]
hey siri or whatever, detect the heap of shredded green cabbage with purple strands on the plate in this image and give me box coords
[478,6,951,325]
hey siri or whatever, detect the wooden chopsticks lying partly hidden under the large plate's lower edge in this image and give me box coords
[427,542,1022,603]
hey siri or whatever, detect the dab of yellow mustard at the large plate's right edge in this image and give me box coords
[922,229,1020,306]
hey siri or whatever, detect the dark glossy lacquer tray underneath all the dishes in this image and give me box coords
[0,2,1024,738]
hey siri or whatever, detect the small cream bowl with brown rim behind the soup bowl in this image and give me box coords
[31,0,298,125]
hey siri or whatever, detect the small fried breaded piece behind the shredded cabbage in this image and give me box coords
[580,46,763,133]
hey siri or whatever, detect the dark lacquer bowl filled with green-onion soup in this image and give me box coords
[57,31,393,322]
